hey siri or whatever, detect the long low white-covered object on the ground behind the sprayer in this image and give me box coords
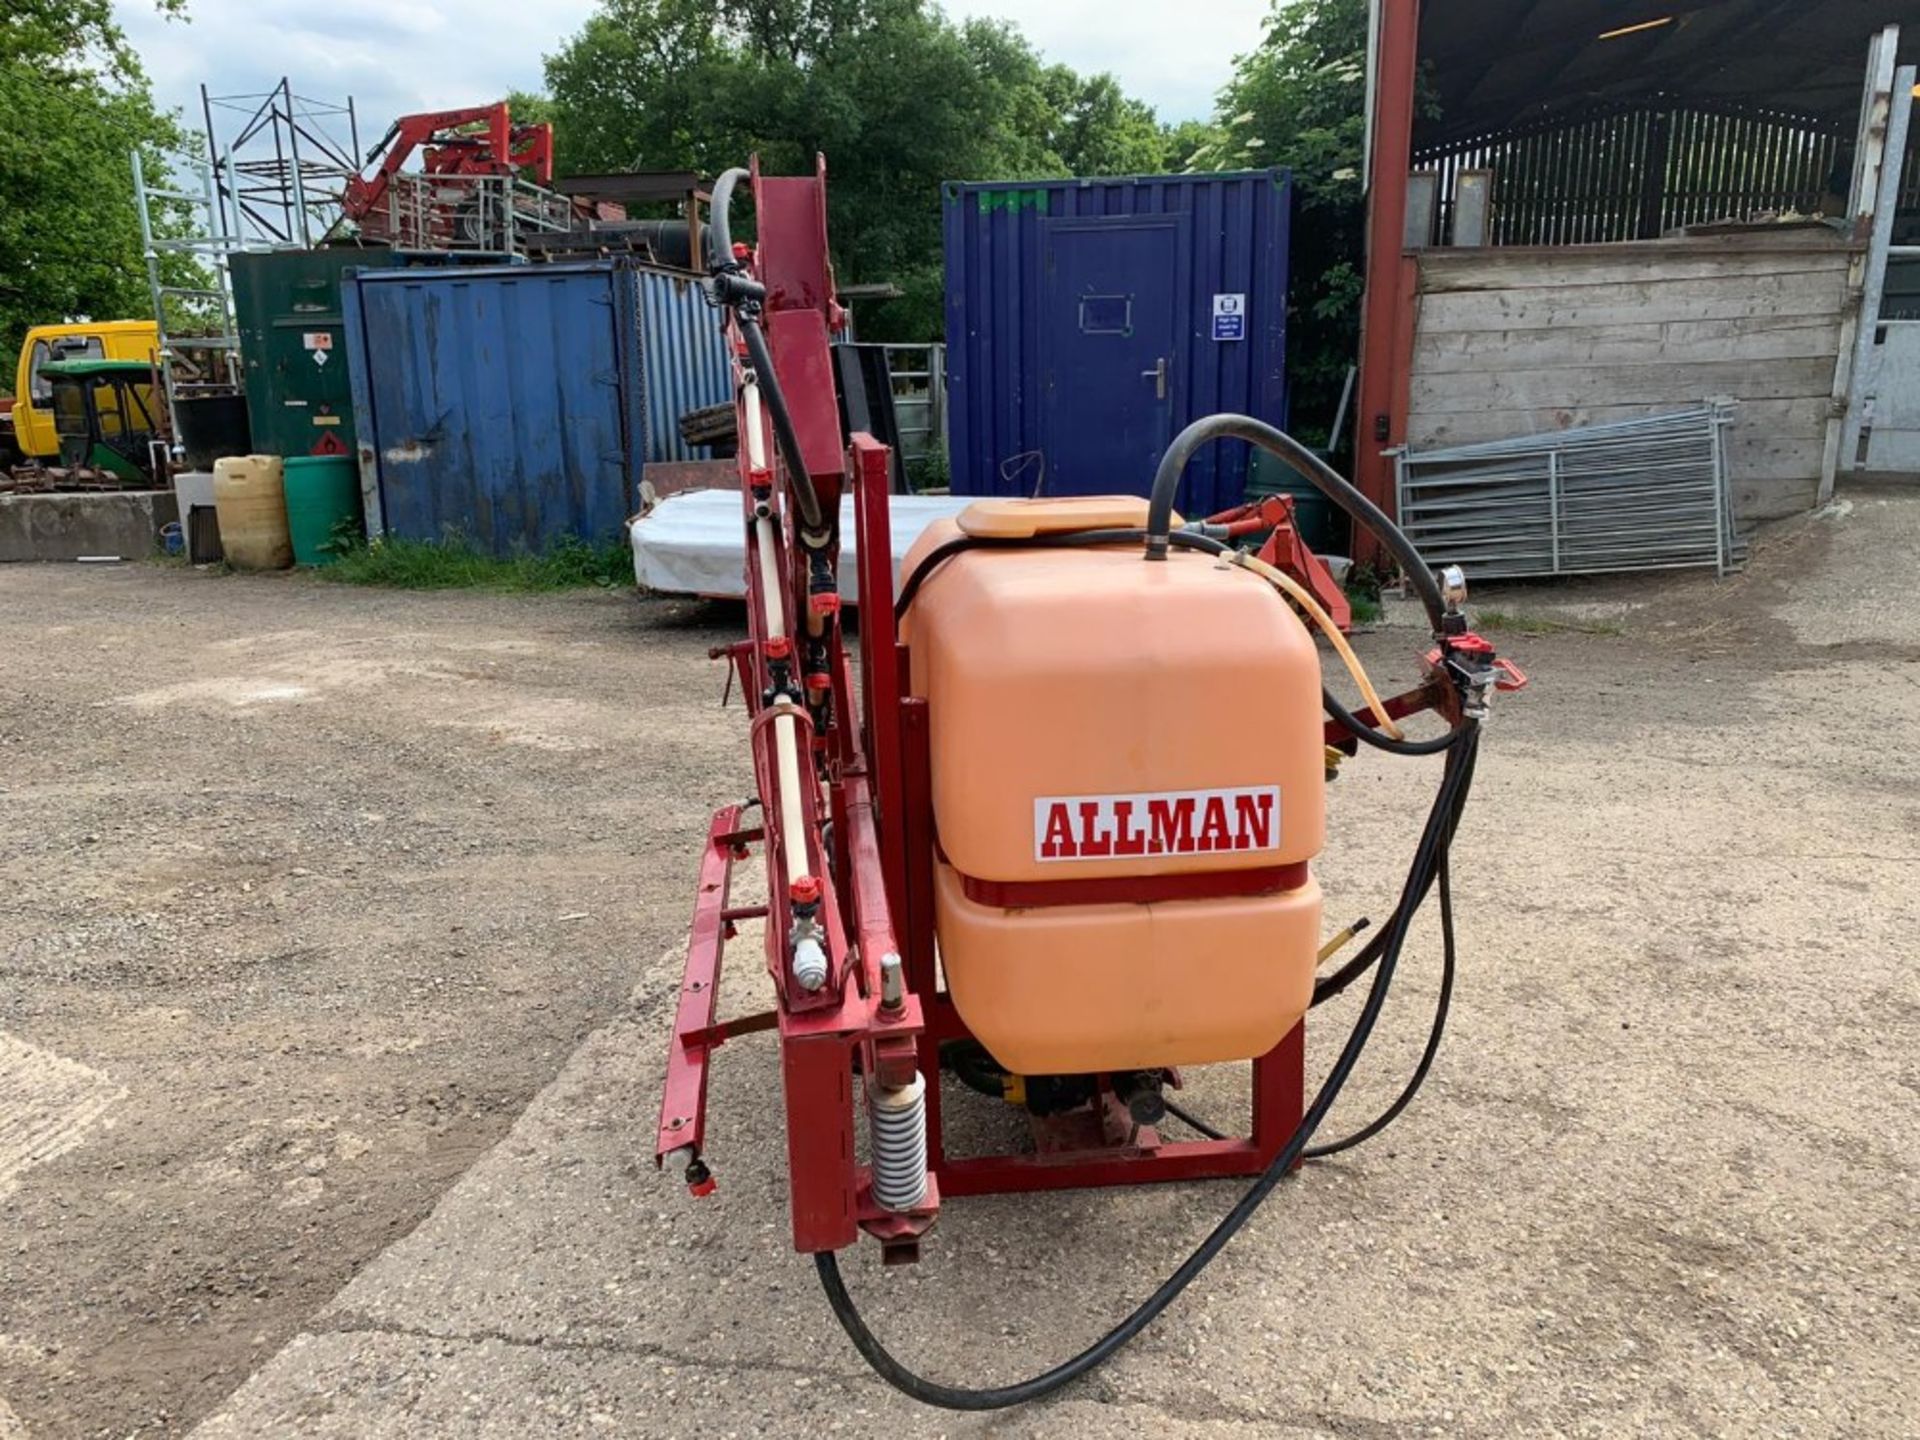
[628,490,973,603]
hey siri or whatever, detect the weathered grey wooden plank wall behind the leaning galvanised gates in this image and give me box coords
[1407,230,1855,520]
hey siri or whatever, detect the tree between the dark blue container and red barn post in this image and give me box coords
[1192,0,1367,451]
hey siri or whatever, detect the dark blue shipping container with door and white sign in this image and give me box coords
[943,169,1292,515]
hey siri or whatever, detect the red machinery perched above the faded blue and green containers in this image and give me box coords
[340,100,553,244]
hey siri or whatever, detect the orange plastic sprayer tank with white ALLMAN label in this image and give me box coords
[904,499,1325,1075]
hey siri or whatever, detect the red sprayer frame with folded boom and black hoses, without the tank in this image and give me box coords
[657,161,1524,1409]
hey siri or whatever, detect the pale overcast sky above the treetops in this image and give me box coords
[115,0,1267,160]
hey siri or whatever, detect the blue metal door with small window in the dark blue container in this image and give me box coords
[1041,215,1181,495]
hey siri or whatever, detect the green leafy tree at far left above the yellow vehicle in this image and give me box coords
[0,0,184,390]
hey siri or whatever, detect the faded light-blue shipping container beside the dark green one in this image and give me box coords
[342,261,732,555]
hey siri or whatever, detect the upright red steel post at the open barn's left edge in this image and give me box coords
[1354,0,1421,563]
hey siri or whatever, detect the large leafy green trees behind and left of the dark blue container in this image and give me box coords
[541,0,1175,342]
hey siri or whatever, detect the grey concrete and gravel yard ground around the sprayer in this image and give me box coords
[0,492,1920,1440]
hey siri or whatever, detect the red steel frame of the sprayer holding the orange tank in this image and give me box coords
[657,165,1328,1260]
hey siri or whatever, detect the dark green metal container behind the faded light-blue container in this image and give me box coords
[227,246,399,455]
